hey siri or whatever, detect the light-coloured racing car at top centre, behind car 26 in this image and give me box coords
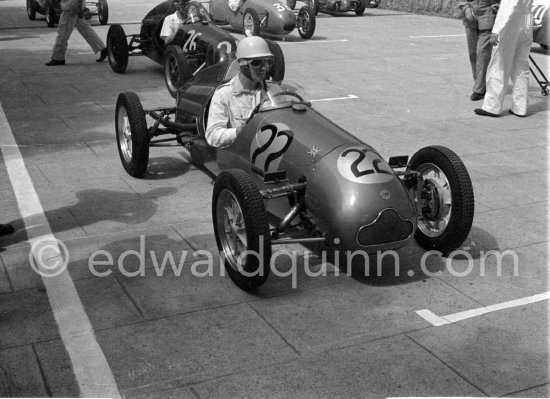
[210,0,315,39]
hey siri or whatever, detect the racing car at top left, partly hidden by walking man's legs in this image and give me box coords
[27,0,109,28]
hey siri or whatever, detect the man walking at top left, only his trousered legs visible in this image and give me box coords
[46,0,107,66]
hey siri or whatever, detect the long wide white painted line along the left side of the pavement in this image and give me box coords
[0,104,120,398]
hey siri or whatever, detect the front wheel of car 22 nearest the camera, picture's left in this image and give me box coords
[212,169,271,290]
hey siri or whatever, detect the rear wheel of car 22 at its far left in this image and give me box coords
[115,92,149,177]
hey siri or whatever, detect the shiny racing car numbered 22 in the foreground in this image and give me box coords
[115,61,474,290]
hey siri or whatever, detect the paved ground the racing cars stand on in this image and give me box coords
[0,0,550,398]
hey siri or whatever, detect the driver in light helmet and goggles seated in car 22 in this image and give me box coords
[205,36,273,147]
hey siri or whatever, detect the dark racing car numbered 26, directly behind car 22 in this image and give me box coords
[107,0,285,97]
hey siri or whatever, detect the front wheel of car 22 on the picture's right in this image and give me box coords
[409,146,474,254]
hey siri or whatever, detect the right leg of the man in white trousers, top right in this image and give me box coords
[510,21,533,116]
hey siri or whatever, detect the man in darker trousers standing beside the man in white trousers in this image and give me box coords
[458,0,500,101]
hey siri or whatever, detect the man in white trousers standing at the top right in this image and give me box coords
[474,0,533,118]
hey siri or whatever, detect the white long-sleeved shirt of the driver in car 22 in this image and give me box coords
[205,73,262,147]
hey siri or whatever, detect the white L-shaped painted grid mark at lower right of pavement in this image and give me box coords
[416,291,550,326]
